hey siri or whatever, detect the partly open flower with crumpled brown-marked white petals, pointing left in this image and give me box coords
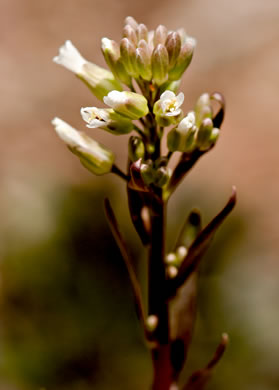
[80,107,134,135]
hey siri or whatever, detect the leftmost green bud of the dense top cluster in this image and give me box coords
[102,38,131,85]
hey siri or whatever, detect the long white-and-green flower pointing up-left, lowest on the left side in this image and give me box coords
[52,118,114,175]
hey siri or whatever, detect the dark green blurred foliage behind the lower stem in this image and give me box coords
[0,181,279,390]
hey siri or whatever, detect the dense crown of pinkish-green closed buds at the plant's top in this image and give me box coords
[102,16,196,86]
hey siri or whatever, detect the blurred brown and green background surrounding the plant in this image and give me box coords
[0,0,279,390]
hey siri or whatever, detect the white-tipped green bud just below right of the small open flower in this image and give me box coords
[167,111,197,152]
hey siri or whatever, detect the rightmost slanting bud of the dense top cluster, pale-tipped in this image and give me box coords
[169,37,196,80]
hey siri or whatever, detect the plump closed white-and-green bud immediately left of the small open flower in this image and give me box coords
[104,91,149,120]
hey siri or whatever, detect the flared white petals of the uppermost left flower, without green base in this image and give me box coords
[53,40,87,75]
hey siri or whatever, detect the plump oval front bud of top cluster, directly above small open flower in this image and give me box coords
[151,44,169,86]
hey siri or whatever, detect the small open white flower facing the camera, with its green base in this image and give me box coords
[153,91,184,126]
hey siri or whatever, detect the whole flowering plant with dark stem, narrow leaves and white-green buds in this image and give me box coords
[52,17,236,390]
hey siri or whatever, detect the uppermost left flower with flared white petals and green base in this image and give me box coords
[53,41,122,100]
